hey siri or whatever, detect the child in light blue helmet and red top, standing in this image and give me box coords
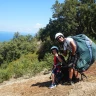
[49,46,63,88]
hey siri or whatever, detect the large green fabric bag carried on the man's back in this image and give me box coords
[70,34,93,72]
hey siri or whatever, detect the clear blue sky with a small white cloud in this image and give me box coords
[0,0,64,34]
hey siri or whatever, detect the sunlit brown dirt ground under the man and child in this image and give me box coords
[0,63,96,96]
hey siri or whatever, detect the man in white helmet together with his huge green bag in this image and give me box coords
[55,32,96,84]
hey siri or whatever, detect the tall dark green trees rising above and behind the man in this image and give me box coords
[39,0,96,41]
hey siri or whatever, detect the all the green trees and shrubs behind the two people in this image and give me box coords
[0,0,96,82]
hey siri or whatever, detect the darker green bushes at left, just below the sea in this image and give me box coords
[0,32,37,64]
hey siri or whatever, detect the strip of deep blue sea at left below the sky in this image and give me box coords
[0,31,35,42]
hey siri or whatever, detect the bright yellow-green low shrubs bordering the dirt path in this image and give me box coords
[0,53,53,82]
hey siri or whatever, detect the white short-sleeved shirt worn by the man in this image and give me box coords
[63,37,74,51]
